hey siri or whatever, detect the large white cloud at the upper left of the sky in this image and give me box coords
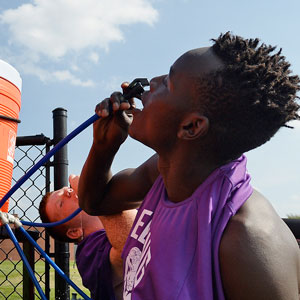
[0,0,158,86]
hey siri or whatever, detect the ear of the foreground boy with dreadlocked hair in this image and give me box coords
[177,112,209,140]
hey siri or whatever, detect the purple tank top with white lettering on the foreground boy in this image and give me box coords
[122,156,252,300]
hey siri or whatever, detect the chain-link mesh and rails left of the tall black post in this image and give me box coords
[0,135,51,300]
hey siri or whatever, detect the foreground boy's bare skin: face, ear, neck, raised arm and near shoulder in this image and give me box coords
[79,48,299,300]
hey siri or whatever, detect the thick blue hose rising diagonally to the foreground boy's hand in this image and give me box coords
[0,114,99,208]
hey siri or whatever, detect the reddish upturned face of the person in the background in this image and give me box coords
[46,187,79,222]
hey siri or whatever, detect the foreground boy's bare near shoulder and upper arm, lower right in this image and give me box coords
[219,191,300,300]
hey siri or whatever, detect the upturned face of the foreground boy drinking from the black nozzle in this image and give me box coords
[129,48,223,153]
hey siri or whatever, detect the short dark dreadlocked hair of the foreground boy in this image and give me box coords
[197,32,300,160]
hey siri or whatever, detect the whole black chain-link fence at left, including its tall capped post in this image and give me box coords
[0,108,75,300]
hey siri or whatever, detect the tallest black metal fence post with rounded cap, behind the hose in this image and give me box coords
[52,108,70,300]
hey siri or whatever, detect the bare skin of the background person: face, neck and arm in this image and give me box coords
[45,174,136,299]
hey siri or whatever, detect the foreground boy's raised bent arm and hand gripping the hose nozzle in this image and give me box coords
[78,89,158,215]
